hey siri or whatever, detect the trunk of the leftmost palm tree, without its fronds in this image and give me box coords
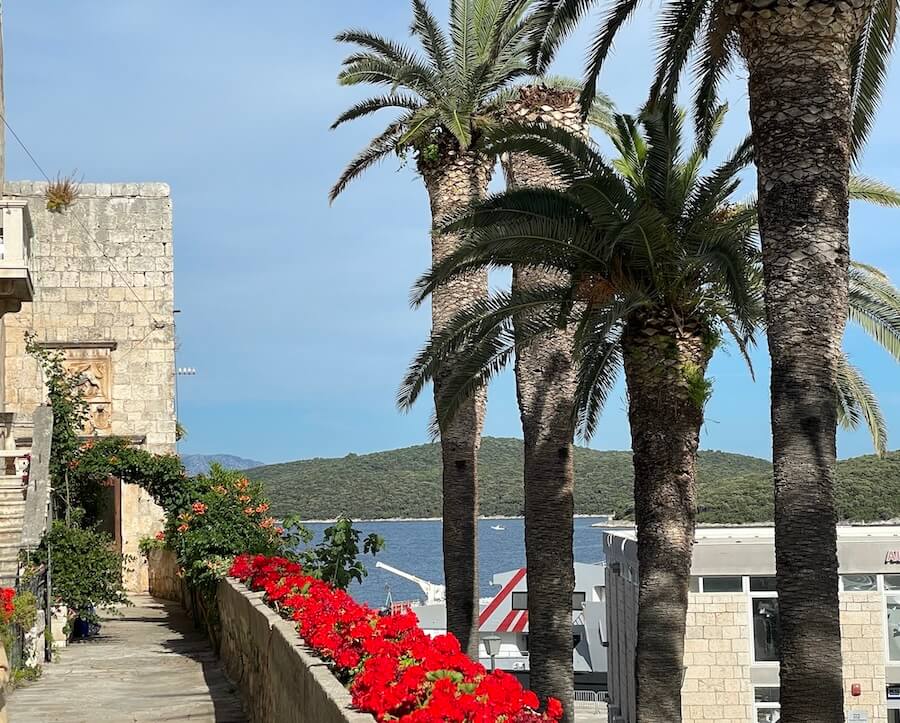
[418,144,493,660]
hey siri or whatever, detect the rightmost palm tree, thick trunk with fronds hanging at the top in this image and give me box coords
[533,0,898,723]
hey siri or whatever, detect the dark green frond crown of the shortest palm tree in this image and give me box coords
[399,111,760,435]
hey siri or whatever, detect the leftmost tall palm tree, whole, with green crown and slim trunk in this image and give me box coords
[331,0,531,657]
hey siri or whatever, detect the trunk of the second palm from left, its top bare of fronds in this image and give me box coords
[503,86,587,723]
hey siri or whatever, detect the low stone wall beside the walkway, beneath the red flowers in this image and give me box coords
[218,579,373,723]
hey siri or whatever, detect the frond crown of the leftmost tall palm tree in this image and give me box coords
[331,0,532,200]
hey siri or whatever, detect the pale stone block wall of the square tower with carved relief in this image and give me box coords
[0,181,175,590]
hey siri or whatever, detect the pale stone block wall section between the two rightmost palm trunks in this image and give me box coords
[681,593,753,723]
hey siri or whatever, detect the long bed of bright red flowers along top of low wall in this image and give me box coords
[229,555,562,723]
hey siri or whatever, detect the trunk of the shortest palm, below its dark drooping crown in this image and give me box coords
[622,313,711,723]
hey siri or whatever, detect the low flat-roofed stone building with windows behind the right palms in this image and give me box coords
[604,526,900,723]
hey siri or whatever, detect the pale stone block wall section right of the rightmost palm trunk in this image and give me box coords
[841,592,887,723]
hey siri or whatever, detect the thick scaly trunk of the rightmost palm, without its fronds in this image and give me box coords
[737,0,867,723]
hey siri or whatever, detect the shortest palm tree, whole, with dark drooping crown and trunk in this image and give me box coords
[400,104,759,723]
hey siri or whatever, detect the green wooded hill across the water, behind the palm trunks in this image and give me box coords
[247,437,800,522]
